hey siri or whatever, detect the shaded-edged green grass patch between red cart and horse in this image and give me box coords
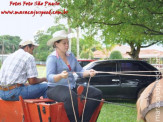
[97,99,137,122]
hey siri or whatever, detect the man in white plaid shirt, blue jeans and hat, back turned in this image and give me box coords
[0,40,47,101]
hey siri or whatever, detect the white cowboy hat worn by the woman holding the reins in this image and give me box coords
[47,30,68,46]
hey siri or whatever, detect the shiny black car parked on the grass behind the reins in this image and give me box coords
[76,60,161,99]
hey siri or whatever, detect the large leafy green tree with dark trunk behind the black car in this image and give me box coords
[60,0,163,59]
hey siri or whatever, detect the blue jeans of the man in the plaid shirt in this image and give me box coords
[0,83,48,101]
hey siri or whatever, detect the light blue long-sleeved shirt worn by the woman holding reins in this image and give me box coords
[46,51,84,89]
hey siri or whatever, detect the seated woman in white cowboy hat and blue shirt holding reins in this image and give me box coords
[46,30,102,122]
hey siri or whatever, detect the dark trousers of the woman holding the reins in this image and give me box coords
[47,85,102,122]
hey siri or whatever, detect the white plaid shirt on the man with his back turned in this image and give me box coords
[0,49,38,87]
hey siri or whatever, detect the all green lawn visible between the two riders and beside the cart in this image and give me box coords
[37,66,136,122]
